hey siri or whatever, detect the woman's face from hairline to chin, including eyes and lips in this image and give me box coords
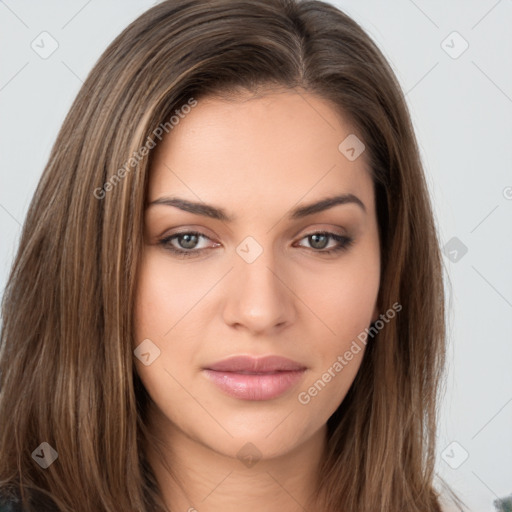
[133,86,380,457]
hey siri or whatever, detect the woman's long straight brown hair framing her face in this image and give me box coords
[0,0,466,512]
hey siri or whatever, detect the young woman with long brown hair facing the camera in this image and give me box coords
[0,0,468,512]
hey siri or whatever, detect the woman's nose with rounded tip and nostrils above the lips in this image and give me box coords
[223,250,296,335]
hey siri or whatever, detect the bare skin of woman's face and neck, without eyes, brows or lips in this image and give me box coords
[134,89,380,512]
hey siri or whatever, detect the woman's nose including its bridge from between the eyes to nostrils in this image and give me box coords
[224,237,295,331]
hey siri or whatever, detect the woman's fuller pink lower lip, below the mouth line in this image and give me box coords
[204,369,305,400]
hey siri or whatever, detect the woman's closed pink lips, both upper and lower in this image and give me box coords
[203,356,306,400]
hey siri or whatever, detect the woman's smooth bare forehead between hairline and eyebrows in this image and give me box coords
[148,90,373,211]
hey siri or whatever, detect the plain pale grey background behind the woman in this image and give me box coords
[0,0,512,512]
